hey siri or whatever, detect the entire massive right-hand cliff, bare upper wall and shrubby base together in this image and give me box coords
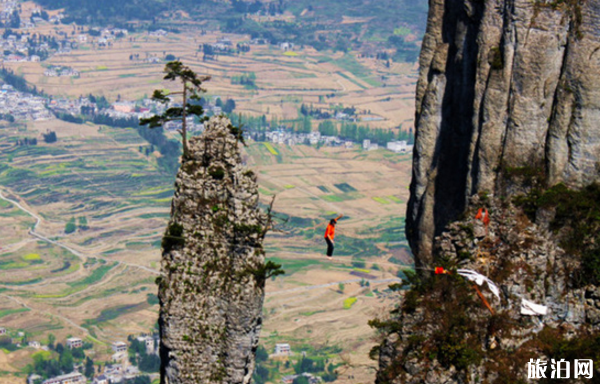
[371,0,600,384]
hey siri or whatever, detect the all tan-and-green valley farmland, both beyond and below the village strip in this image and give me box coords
[0,7,416,383]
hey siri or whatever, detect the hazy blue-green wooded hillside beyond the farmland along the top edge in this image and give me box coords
[31,0,427,62]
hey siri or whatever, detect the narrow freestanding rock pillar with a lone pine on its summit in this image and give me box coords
[159,117,267,384]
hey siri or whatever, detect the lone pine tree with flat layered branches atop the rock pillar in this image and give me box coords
[140,61,210,158]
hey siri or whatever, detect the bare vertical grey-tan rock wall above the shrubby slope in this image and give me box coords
[407,0,600,264]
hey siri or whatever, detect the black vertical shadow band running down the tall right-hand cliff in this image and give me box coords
[433,0,483,246]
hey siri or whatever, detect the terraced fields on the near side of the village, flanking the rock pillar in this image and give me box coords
[0,117,410,375]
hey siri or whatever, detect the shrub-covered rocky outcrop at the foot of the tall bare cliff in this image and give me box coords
[376,196,600,384]
